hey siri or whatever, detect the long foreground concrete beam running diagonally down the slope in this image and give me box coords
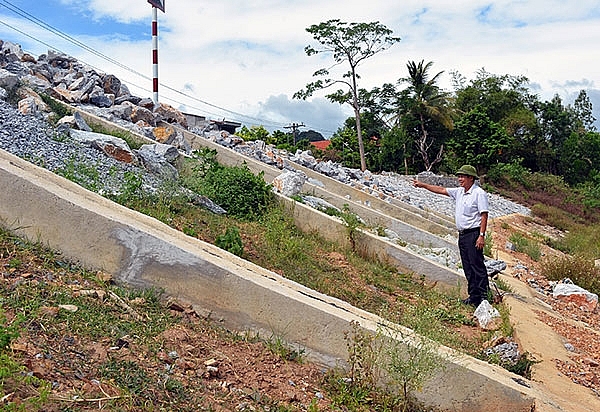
[0,108,552,412]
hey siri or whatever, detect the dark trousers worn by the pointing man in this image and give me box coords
[458,231,490,303]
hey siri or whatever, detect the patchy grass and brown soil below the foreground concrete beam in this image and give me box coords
[0,230,332,412]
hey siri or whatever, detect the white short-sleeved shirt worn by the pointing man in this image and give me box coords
[446,183,489,230]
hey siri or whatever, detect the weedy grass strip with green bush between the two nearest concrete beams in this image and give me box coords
[16,147,520,356]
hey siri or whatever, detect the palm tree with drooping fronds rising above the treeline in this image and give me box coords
[400,60,453,171]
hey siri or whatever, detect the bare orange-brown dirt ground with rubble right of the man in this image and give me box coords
[490,215,600,412]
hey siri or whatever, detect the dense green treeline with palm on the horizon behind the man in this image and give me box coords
[323,62,600,185]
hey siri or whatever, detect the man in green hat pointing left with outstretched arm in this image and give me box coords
[413,165,489,307]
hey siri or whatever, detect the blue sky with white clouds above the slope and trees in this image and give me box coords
[0,0,600,136]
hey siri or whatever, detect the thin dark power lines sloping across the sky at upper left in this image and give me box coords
[0,0,333,133]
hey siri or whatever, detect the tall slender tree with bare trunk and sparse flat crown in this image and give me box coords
[294,19,400,171]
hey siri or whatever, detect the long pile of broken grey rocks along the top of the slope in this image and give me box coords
[0,40,529,222]
